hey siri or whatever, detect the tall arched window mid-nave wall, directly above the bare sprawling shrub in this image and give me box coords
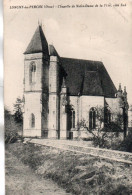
[89,108,96,129]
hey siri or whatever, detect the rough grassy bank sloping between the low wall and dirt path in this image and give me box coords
[6,143,132,195]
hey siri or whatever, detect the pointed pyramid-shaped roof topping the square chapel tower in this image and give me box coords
[24,25,48,55]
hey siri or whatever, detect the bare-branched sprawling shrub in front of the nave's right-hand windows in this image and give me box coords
[78,106,123,148]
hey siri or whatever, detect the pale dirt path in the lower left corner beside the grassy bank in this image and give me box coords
[5,151,71,195]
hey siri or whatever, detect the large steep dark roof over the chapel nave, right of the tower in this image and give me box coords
[61,57,117,97]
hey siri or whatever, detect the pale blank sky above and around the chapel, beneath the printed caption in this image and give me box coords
[4,0,132,110]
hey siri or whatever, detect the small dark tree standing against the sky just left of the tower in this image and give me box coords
[14,97,23,123]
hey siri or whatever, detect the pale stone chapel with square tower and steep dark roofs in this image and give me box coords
[23,25,127,139]
